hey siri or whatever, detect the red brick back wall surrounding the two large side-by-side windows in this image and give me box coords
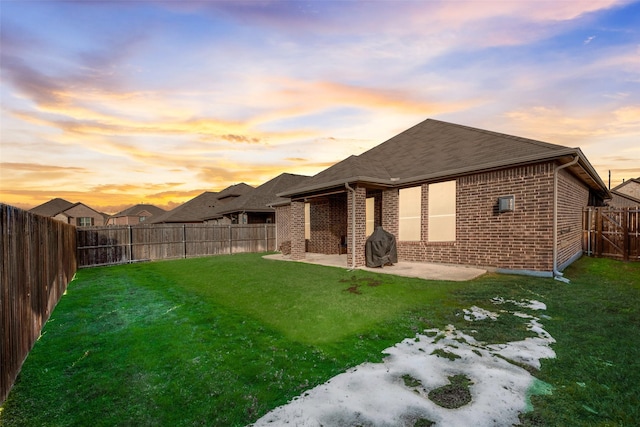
[383,163,553,271]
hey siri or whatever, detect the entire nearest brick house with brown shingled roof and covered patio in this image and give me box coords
[276,119,611,276]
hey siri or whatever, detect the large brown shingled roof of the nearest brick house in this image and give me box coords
[278,119,610,198]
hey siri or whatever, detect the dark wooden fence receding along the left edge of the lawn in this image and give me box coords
[0,204,76,403]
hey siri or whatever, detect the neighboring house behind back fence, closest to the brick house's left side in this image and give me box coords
[206,173,310,224]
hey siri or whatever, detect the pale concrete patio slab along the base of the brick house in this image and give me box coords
[263,252,487,282]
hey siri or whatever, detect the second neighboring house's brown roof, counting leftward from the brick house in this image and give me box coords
[147,183,253,224]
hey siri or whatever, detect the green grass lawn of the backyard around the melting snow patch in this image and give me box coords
[0,254,640,426]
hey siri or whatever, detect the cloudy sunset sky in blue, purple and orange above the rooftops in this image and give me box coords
[0,0,640,213]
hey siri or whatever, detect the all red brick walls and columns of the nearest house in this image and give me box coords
[277,163,589,272]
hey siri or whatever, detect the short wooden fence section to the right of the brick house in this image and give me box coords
[582,207,640,261]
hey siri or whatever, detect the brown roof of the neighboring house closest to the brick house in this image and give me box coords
[211,173,311,218]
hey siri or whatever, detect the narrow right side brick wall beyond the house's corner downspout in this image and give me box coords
[557,169,589,267]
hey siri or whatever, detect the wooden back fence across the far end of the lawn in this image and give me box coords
[77,224,276,267]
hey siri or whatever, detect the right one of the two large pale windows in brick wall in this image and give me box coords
[428,181,456,242]
